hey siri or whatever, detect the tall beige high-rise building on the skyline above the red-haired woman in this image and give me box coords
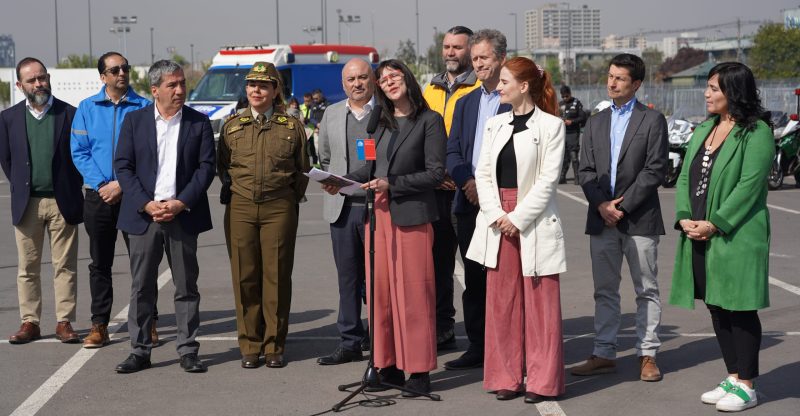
[525,3,600,50]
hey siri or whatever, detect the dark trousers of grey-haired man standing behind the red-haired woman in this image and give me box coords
[456,212,486,353]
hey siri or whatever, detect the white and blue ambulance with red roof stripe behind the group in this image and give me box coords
[186,44,379,138]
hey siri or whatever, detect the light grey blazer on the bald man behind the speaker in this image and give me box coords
[317,99,365,224]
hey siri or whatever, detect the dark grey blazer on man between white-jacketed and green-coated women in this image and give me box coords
[578,101,668,235]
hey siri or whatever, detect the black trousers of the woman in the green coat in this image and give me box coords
[707,305,761,380]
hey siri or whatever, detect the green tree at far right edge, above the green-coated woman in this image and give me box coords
[750,23,800,79]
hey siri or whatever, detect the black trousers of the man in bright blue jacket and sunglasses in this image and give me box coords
[83,189,158,324]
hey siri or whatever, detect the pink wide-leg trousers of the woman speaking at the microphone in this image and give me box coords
[365,192,436,373]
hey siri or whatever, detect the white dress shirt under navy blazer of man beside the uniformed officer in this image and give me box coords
[153,104,183,201]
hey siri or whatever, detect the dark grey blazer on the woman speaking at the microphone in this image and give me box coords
[347,110,447,226]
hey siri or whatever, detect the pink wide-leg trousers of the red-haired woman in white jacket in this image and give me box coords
[483,188,565,396]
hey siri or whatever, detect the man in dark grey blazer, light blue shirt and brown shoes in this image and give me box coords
[571,54,667,381]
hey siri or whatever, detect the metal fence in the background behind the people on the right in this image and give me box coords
[572,80,798,118]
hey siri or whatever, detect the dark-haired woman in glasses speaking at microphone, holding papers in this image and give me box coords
[329,59,447,397]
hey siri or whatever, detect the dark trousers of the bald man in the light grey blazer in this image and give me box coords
[331,205,366,351]
